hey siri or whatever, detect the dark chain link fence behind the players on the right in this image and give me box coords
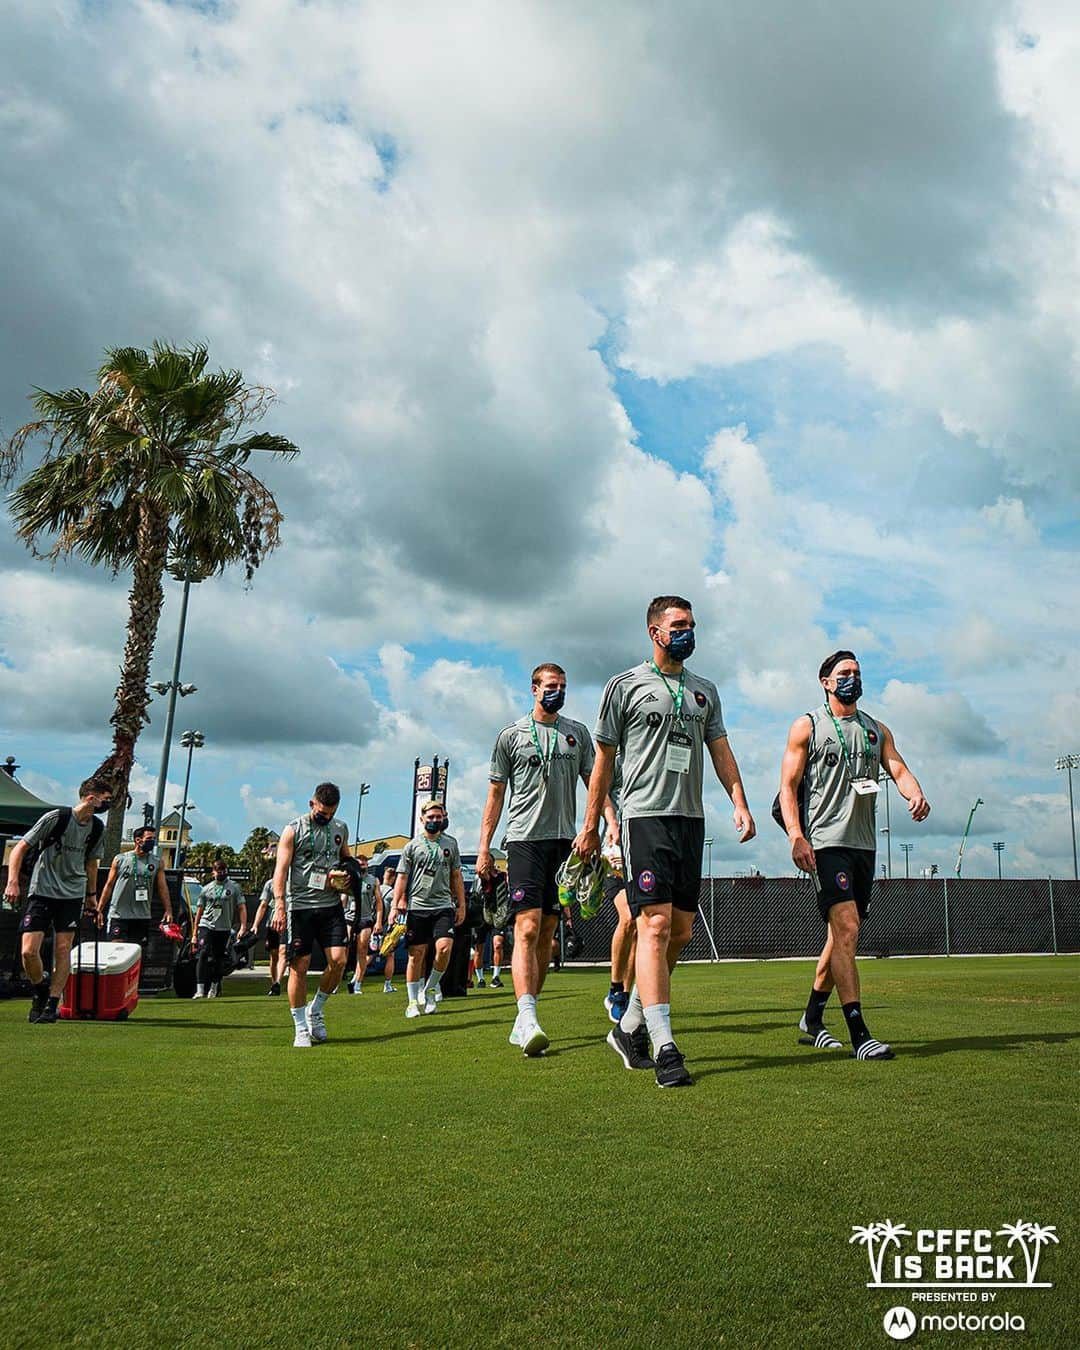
[574,876,1080,963]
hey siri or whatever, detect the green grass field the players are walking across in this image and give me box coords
[0,957,1080,1350]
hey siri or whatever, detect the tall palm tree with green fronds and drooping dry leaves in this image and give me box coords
[0,342,298,860]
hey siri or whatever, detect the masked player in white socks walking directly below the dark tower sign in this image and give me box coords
[394,802,464,1018]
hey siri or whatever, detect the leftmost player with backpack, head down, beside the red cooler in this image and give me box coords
[4,778,112,1022]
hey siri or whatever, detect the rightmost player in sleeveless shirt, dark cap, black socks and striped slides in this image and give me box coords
[780,651,930,1060]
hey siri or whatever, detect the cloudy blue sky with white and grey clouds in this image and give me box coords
[0,0,1080,876]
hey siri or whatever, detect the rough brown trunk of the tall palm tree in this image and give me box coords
[99,504,169,867]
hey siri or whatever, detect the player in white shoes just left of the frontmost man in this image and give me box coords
[477,662,614,1056]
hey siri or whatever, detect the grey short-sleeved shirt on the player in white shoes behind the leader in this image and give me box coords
[489,716,597,844]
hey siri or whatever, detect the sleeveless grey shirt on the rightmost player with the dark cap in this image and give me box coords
[806,703,882,853]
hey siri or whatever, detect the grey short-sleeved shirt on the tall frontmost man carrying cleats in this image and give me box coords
[597,662,728,821]
